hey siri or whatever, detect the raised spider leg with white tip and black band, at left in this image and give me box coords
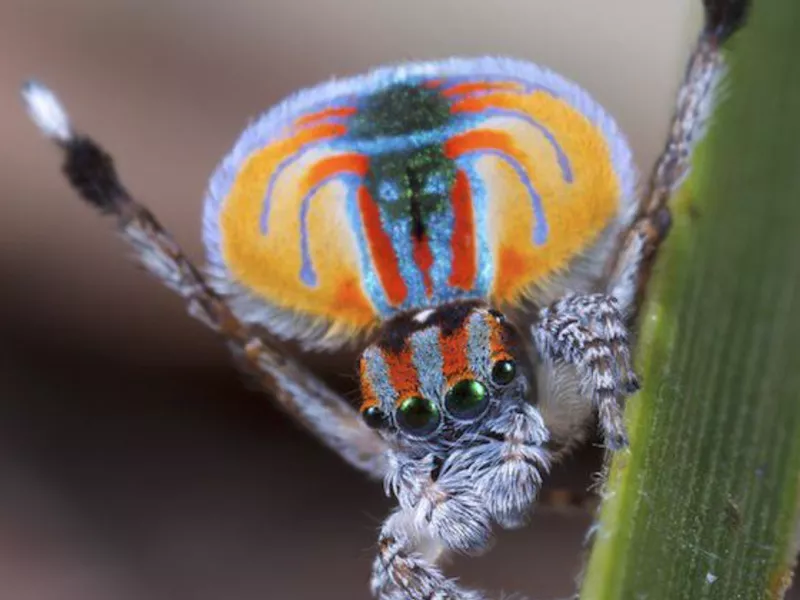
[23,83,386,478]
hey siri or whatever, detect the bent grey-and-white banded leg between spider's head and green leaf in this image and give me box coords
[532,294,639,450]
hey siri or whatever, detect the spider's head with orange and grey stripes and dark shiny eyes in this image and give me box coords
[360,302,530,450]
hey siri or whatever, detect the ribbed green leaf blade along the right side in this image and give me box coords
[581,0,800,600]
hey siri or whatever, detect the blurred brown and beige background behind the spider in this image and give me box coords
[0,0,788,600]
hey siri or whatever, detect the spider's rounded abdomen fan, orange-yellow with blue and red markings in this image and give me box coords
[204,58,635,346]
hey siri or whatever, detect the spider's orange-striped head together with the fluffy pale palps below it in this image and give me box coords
[360,302,548,536]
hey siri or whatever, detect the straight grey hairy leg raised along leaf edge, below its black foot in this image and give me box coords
[609,31,724,318]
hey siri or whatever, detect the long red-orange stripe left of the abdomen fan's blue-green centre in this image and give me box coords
[358,185,408,306]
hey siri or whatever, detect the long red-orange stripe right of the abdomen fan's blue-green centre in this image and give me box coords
[447,171,478,290]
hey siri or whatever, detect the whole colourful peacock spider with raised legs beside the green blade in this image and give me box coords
[23,35,720,600]
